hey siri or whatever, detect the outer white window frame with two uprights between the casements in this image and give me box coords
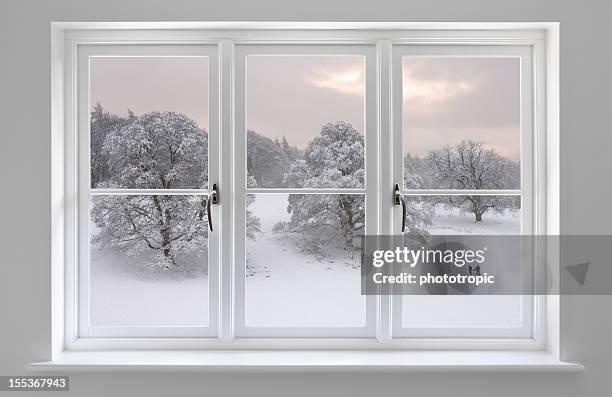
[44,22,571,370]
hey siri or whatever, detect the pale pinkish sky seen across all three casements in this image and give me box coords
[90,55,520,160]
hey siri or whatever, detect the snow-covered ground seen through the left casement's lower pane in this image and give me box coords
[90,248,208,326]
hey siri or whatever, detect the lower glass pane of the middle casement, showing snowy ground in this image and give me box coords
[245,194,365,327]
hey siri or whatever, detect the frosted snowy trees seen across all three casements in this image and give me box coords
[90,104,520,268]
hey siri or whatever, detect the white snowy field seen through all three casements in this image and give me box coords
[90,194,521,327]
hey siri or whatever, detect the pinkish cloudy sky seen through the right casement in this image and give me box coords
[402,57,520,161]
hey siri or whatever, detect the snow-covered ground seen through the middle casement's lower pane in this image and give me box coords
[245,194,365,327]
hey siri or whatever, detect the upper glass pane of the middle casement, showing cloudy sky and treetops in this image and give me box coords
[246,55,365,188]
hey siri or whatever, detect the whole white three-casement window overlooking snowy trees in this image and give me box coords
[54,27,558,356]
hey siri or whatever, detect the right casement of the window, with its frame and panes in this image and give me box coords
[393,45,537,337]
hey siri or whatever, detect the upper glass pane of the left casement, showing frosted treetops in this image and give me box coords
[89,57,208,189]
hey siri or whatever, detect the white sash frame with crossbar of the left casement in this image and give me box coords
[73,42,220,338]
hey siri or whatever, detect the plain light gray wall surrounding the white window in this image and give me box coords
[0,0,612,396]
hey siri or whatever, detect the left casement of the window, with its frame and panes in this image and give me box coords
[78,45,219,337]
